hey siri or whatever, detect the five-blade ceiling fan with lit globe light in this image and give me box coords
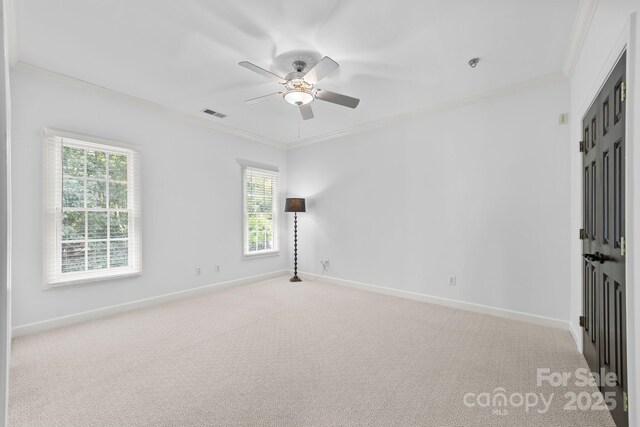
[238,56,360,120]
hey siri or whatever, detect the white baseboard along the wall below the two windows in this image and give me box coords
[11,270,288,337]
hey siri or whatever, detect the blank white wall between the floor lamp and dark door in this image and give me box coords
[288,83,571,320]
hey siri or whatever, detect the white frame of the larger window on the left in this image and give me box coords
[43,129,142,288]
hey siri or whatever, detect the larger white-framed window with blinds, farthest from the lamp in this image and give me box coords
[45,132,141,286]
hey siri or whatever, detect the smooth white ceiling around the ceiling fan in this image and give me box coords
[15,0,580,143]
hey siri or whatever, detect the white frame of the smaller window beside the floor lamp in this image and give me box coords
[239,164,280,258]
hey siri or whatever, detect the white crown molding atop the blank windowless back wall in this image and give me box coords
[287,72,567,150]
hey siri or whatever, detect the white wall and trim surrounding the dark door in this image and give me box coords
[570,0,640,425]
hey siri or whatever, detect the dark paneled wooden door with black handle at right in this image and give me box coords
[581,54,628,426]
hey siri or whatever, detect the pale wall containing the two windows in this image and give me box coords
[11,69,287,326]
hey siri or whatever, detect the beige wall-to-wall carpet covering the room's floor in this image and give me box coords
[9,278,613,427]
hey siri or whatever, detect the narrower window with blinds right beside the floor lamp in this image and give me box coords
[243,166,278,255]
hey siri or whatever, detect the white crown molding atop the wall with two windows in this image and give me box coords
[11,61,287,149]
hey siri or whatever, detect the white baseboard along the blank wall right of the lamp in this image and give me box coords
[298,271,576,332]
